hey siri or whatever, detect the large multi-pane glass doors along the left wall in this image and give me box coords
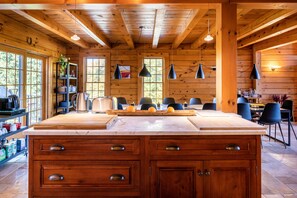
[0,48,43,125]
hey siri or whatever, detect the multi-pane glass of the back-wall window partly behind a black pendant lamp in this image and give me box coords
[143,58,163,103]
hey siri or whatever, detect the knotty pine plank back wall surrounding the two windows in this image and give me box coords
[67,44,252,106]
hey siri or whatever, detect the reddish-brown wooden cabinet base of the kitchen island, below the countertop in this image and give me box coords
[29,135,261,198]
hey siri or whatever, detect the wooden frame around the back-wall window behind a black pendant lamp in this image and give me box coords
[137,53,170,102]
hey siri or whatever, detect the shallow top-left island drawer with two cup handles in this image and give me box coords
[33,137,140,160]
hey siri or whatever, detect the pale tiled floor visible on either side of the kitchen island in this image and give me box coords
[0,123,297,198]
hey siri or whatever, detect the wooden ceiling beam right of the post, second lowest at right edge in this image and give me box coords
[237,16,297,48]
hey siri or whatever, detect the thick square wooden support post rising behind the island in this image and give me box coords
[216,3,237,113]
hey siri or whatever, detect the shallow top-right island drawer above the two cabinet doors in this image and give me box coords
[150,136,256,156]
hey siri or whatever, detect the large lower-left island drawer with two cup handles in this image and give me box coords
[34,161,140,195]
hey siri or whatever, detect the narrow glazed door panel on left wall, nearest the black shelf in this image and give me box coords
[26,57,43,125]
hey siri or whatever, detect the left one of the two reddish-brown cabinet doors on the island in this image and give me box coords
[150,161,203,198]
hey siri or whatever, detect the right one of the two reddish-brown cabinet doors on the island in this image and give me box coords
[204,160,256,198]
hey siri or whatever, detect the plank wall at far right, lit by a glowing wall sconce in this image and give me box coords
[261,44,297,118]
